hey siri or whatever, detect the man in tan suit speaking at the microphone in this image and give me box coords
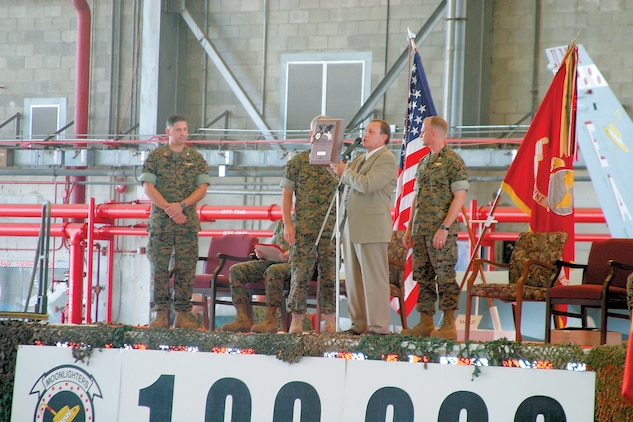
[330,120,398,335]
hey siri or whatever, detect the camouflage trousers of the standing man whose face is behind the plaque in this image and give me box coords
[287,236,336,314]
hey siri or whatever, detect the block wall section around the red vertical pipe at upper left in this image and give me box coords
[0,0,138,139]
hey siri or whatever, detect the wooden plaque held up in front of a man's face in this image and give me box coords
[310,119,345,167]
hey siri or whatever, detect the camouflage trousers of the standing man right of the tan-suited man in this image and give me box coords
[413,234,459,315]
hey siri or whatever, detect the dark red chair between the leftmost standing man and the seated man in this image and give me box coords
[192,234,256,330]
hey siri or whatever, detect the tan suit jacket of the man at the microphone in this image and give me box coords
[342,148,398,243]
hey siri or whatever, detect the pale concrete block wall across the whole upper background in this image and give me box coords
[0,0,633,139]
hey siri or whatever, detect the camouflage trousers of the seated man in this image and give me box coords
[229,259,290,308]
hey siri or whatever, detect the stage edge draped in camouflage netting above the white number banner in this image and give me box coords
[0,321,633,422]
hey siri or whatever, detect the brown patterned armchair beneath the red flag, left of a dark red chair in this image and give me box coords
[464,232,567,341]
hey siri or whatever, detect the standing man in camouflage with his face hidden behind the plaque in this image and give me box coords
[280,116,338,333]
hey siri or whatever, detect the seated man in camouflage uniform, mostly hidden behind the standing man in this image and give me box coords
[220,221,290,333]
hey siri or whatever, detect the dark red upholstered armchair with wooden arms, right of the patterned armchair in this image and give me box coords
[545,239,633,344]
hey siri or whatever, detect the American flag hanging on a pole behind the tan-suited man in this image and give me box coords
[391,49,437,315]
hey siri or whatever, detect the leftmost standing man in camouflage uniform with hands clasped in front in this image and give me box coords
[139,114,211,328]
